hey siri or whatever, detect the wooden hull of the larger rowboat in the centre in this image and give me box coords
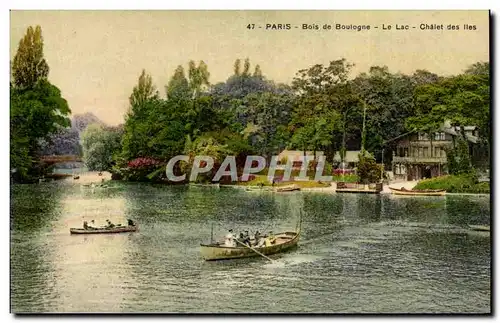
[201,232,300,261]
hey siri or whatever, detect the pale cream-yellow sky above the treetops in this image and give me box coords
[10,10,489,125]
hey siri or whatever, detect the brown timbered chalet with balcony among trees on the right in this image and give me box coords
[392,126,478,181]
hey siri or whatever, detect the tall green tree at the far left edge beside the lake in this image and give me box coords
[10,26,71,181]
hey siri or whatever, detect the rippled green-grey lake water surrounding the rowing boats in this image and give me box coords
[10,181,491,313]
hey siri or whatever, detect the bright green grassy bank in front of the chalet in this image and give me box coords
[414,175,490,194]
